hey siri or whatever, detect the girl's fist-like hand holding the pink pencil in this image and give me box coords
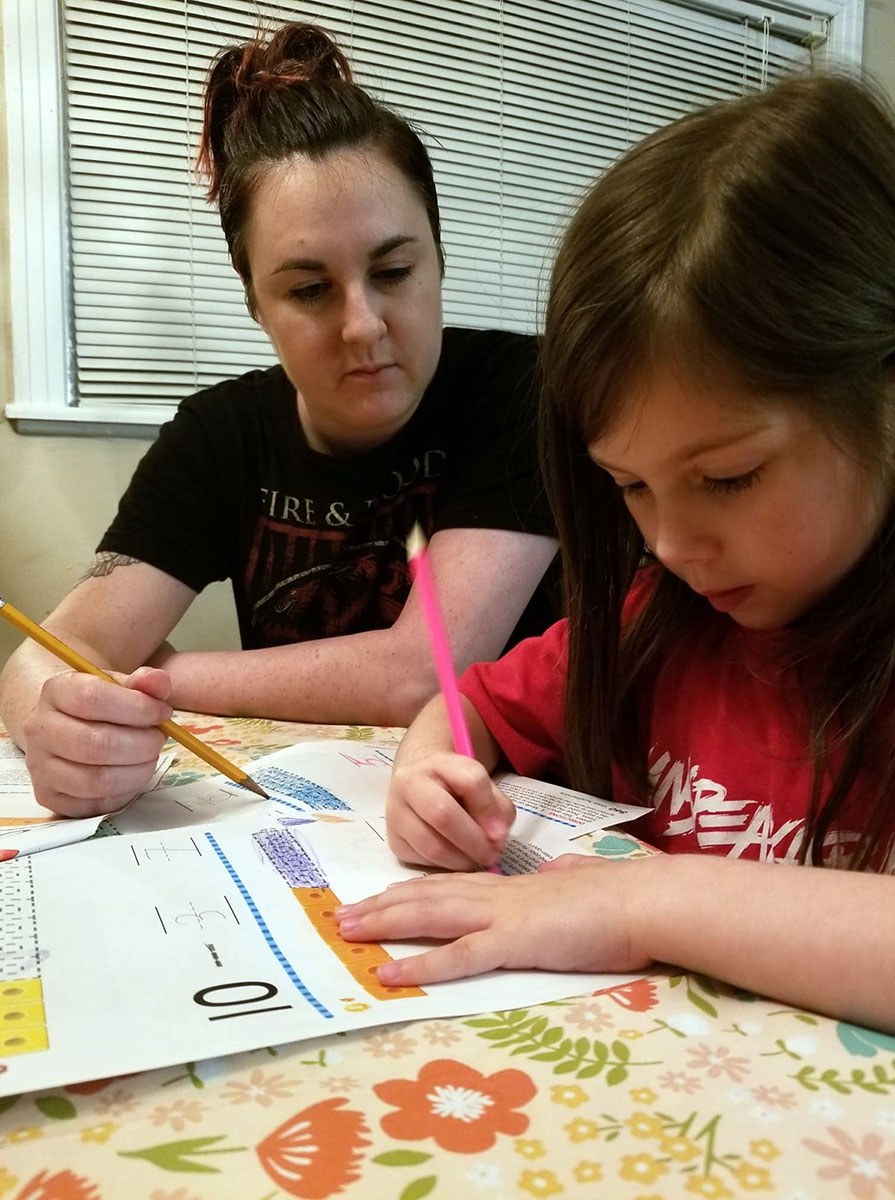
[385,751,516,871]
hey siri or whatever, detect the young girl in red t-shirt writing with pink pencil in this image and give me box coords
[341,76,895,1030]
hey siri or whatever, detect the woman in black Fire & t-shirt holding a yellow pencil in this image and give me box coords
[0,24,555,816]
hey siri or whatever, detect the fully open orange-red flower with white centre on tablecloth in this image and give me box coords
[373,1058,536,1154]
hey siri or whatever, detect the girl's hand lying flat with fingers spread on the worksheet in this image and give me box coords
[336,854,661,986]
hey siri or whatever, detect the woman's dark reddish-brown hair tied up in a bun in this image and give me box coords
[197,22,444,312]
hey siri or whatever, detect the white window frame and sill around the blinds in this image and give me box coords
[2,0,864,437]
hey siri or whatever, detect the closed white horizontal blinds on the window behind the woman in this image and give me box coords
[62,0,812,420]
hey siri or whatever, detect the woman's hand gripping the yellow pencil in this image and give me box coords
[23,667,172,817]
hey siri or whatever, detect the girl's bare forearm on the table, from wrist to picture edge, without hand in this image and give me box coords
[636,854,895,1031]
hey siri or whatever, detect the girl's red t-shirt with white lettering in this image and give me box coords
[461,569,887,865]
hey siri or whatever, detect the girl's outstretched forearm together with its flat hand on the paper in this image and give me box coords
[340,854,895,1031]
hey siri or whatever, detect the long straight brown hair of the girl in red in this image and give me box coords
[541,74,895,866]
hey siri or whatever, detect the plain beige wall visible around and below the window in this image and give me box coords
[0,0,895,665]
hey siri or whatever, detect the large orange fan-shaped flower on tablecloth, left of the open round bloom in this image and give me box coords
[256,1097,370,1200]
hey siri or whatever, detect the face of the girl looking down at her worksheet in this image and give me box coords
[589,371,884,629]
